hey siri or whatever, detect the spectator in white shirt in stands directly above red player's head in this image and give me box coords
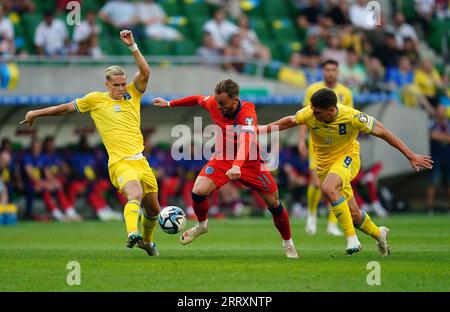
[203,9,239,49]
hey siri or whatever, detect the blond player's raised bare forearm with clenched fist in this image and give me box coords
[120,29,150,93]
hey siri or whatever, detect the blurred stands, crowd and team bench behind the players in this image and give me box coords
[0,0,450,223]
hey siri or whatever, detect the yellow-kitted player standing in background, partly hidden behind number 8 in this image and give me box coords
[298,60,353,236]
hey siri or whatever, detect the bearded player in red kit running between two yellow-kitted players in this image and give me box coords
[153,79,298,259]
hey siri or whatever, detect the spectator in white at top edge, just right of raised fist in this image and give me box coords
[136,0,183,41]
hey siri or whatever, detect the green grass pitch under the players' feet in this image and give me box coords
[0,215,450,292]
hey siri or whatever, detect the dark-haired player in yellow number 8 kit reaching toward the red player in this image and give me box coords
[259,88,433,256]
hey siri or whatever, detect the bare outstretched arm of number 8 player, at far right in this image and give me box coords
[371,121,433,171]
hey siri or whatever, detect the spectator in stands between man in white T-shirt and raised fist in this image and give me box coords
[73,11,102,58]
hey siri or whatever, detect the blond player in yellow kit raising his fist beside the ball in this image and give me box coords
[21,30,160,256]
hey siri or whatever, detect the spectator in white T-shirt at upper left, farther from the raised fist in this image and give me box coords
[34,11,69,56]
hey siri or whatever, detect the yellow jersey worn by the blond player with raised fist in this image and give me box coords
[74,83,144,166]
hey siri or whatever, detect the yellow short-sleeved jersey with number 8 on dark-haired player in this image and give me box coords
[295,104,376,170]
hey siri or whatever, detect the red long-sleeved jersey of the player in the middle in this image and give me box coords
[170,95,260,165]
